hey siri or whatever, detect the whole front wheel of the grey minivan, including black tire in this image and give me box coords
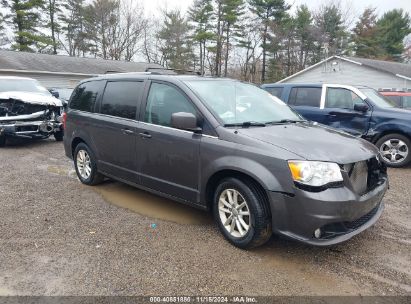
[213,178,272,249]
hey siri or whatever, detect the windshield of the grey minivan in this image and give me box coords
[185,80,304,126]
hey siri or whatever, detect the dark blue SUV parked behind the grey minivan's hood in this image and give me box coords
[262,83,411,167]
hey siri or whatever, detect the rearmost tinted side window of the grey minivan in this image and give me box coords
[70,81,104,112]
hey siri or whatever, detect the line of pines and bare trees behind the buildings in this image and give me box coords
[0,0,411,83]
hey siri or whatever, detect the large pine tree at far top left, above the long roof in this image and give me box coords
[2,0,52,52]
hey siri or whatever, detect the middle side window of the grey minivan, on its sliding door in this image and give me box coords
[101,81,143,119]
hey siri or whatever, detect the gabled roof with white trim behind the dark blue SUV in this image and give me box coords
[279,56,411,82]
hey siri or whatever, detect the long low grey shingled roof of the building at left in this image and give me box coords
[0,50,161,75]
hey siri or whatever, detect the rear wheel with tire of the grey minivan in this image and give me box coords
[74,143,104,186]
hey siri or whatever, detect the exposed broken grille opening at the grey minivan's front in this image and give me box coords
[344,157,387,195]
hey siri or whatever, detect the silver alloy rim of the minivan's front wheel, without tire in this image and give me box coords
[218,189,251,238]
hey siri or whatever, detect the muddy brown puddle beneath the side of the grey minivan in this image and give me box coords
[93,182,212,225]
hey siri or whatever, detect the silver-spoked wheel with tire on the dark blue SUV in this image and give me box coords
[376,133,411,168]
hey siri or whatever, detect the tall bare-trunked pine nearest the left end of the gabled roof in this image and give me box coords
[249,0,290,82]
